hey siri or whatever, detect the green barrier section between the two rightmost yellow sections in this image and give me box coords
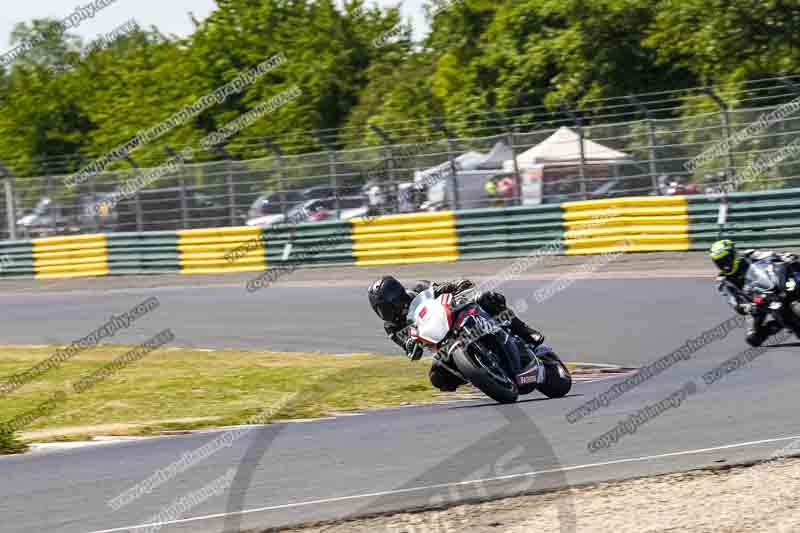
[456,204,564,259]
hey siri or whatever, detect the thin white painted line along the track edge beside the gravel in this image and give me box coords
[90,435,800,533]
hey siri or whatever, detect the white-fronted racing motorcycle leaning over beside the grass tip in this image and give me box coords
[407,287,572,403]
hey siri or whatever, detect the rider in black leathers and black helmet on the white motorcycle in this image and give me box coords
[369,276,544,391]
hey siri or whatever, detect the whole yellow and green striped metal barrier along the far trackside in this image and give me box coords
[10,189,800,279]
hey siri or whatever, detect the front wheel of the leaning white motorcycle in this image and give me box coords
[453,342,519,403]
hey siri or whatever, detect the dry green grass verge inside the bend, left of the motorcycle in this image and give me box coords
[0,346,440,446]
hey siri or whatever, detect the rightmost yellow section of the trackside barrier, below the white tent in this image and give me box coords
[562,196,690,255]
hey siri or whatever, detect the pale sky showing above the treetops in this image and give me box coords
[0,0,426,49]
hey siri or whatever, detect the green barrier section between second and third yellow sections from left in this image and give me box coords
[263,217,355,268]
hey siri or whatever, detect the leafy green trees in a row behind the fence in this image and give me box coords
[0,0,800,187]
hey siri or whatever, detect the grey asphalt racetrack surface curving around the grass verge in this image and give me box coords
[0,250,800,533]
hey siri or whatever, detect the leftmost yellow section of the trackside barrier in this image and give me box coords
[32,235,108,279]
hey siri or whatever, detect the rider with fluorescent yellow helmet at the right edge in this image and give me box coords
[710,240,800,346]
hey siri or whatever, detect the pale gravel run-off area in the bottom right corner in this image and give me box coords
[293,458,800,533]
